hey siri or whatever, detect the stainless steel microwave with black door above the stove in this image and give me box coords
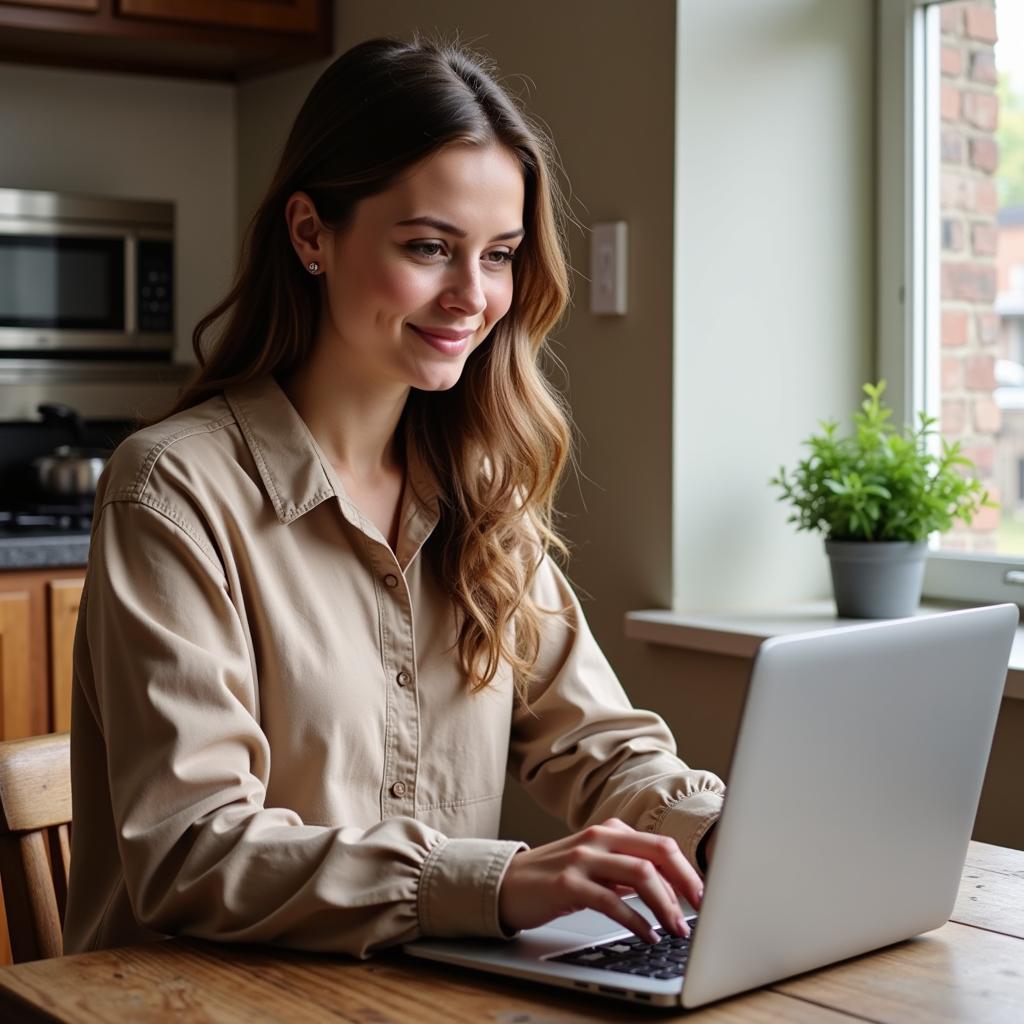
[0,188,174,361]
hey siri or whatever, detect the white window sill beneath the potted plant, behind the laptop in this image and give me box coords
[626,601,1024,700]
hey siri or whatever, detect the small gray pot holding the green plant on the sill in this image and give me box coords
[825,541,928,618]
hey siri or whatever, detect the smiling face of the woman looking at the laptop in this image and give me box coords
[305,143,524,391]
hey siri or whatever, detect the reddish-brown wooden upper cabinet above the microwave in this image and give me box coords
[0,0,334,82]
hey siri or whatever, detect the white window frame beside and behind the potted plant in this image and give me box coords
[877,0,1024,604]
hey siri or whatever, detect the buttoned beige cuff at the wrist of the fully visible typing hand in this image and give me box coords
[417,839,529,939]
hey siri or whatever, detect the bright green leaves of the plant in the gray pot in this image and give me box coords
[770,381,995,541]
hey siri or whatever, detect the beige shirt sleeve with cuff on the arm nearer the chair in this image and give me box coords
[74,501,523,955]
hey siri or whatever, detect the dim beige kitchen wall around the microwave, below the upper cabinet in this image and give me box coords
[0,63,237,419]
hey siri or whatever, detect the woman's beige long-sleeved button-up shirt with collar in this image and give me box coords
[65,378,723,955]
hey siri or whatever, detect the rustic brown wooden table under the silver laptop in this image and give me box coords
[0,843,1024,1024]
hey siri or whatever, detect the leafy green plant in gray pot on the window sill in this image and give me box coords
[771,381,995,618]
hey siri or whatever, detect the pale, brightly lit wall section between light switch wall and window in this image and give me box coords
[674,0,874,609]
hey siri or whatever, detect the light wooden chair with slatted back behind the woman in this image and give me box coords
[0,732,71,964]
